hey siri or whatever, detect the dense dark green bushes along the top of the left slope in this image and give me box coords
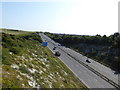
[2,30,42,64]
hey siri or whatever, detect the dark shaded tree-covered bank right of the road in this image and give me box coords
[45,32,120,71]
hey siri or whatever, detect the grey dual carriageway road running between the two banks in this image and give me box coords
[40,33,118,88]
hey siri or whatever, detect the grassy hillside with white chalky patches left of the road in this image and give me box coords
[0,29,87,89]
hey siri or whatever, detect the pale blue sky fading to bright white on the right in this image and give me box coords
[0,0,120,35]
